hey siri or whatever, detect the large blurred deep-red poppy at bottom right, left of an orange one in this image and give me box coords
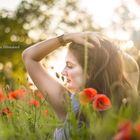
[113,121,133,140]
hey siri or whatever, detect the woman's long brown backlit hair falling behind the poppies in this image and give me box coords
[69,34,136,105]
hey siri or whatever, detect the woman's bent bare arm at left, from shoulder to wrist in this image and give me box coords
[22,37,69,119]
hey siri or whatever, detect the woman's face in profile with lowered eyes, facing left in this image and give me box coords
[62,50,84,92]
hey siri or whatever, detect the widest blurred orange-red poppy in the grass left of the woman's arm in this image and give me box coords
[8,89,25,100]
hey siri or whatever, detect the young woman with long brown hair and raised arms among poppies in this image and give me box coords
[23,32,139,140]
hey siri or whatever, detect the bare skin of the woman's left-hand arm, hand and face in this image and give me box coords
[22,32,139,120]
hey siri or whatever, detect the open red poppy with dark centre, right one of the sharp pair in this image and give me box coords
[92,94,111,111]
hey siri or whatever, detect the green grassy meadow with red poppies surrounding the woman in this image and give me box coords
[0,78,140,140]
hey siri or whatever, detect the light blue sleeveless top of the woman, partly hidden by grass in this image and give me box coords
[53,94,80,140]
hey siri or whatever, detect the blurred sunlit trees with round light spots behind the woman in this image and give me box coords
[0,0,140,89]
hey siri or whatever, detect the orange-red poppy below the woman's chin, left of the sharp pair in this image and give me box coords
[79,88,97,105]
